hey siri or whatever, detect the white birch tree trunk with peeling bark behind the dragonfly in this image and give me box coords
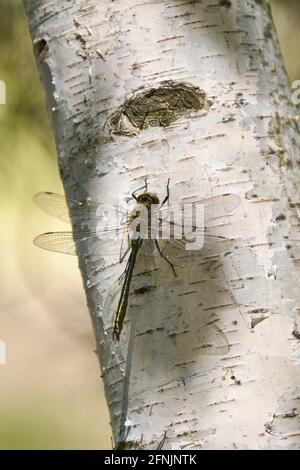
[24,0,300,449]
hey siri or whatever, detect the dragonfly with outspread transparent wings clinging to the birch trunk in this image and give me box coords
[33,179,240,340]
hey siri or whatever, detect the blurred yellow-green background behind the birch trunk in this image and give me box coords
[0,0,300,449]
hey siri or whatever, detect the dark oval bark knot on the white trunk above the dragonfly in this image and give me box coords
[107,81,206,136]
